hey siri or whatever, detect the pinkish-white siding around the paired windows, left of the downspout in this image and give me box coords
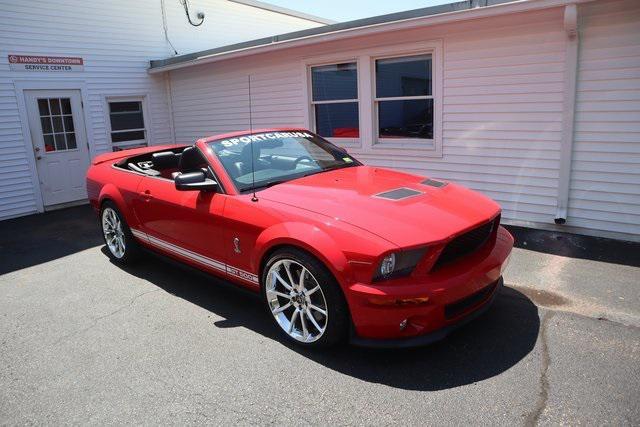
[171,5,564,231]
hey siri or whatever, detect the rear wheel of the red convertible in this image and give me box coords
[100,201,138,264]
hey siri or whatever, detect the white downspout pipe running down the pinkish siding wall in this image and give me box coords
[554,4,580,224]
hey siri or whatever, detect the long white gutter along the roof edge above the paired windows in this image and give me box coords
[148,0,595,74]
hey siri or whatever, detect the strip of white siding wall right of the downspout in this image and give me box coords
[568,0,640,234]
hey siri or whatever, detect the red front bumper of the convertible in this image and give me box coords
[345,227,513,347]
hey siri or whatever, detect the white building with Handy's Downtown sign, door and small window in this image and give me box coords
[0,0,327,219]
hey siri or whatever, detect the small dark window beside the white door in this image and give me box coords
[109,101,147,151]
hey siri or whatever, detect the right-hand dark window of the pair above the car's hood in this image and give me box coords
[375,55,433,139]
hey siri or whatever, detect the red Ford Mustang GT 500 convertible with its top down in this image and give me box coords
[87,129,513,347]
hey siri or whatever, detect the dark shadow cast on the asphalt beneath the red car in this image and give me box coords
[112,248,540,390]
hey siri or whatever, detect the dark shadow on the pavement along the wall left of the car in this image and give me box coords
[0,205,103,274]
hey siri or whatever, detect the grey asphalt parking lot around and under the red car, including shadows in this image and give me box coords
[0,206,640,425]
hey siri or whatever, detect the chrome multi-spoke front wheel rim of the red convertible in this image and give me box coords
[265,259,329,343]
